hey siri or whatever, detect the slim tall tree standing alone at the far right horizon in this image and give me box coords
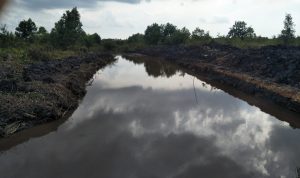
[280,14,295,43]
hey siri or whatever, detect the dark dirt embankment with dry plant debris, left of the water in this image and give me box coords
[0,54,115,136]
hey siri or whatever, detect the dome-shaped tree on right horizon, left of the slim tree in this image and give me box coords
[227,21,256,39]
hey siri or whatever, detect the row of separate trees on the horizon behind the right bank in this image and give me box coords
[128,14,296,45]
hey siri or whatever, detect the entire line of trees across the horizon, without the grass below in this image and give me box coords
[0,7,296,50]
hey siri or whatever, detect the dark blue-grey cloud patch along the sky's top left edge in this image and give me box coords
[16,0,149,10]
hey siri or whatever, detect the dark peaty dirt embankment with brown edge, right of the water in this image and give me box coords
[135,44,300,112]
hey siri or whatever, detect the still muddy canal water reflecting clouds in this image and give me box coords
[0,57,300,178]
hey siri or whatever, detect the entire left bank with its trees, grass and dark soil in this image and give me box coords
[0,8,115,137]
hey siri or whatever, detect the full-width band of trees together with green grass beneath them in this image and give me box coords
[0,8,300,57]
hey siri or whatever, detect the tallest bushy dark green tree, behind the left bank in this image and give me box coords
[51,7,85,48]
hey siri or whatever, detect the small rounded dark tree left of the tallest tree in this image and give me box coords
[15,18,37,40]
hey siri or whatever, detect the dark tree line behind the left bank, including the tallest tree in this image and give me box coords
[0,7,101,49]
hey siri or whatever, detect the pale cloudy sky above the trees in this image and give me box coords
[0,0,300,39]
